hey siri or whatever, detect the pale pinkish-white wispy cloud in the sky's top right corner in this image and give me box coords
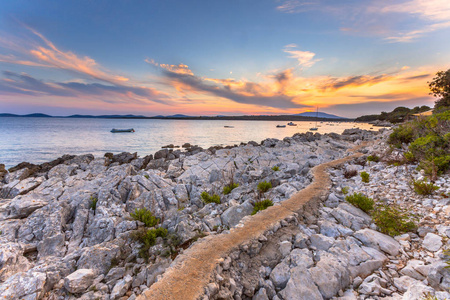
[276,0,450,43]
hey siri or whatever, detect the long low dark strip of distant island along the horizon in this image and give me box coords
[0,112,354,122]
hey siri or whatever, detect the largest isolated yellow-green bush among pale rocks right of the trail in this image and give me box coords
[372,205,417,236]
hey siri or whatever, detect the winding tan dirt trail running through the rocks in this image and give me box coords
[137,145,363,300]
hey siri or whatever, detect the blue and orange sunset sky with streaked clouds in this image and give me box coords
[0,0,450,117]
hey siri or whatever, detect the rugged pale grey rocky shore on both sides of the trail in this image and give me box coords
[0,129,450,299]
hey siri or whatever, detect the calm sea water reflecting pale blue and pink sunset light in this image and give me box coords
[0,118,377,167]
